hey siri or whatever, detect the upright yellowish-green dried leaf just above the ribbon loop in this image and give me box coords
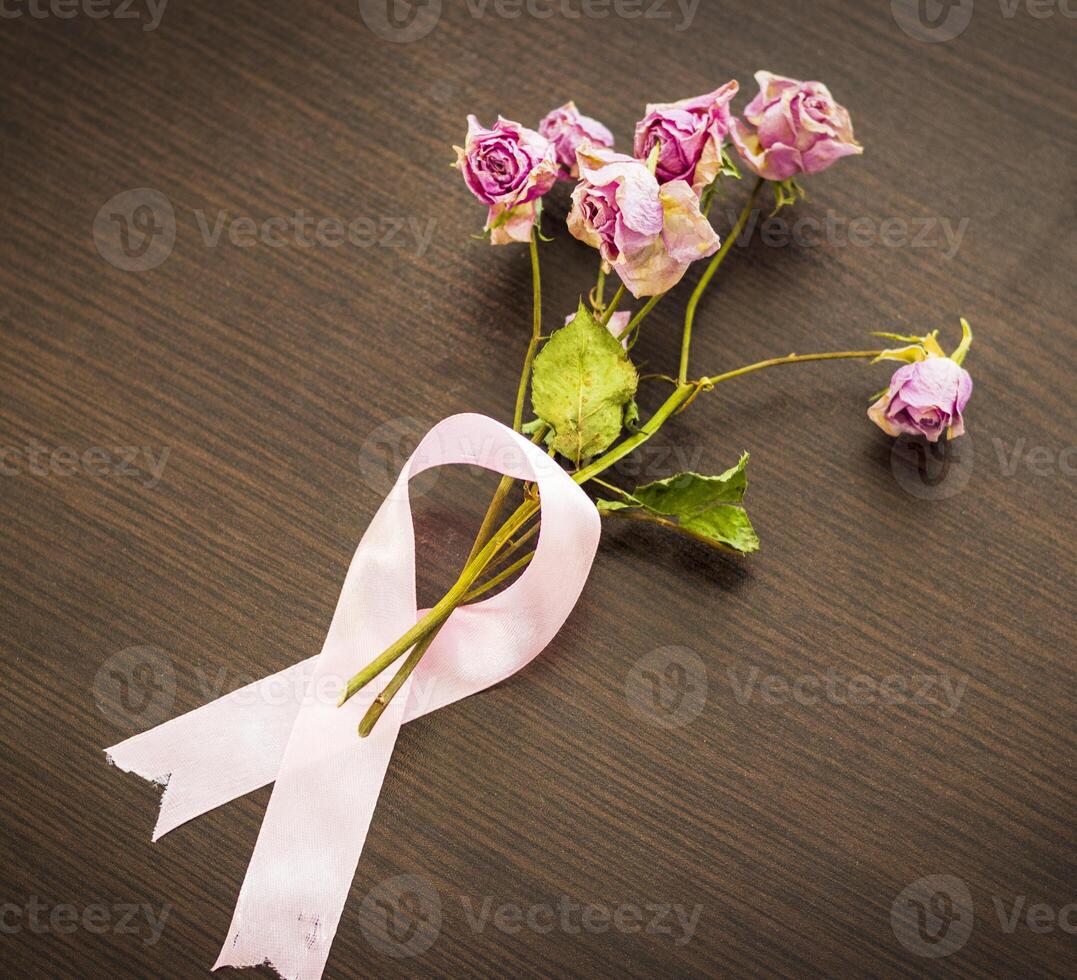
[531,303,640,466]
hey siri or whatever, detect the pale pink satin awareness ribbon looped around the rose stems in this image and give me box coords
[107,415,600,980]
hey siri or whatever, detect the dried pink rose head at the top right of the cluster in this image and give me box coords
[732,71,864,181]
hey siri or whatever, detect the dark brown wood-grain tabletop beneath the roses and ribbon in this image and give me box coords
[0,0,1077,977]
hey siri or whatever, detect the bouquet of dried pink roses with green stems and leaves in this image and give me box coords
[340,71,973,736]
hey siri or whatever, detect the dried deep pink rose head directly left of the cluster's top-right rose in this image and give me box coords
[635,82,740,194]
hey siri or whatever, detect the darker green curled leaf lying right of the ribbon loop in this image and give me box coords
[598,452,759,555]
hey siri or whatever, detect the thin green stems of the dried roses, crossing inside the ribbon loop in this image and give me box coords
[340,179,882,737]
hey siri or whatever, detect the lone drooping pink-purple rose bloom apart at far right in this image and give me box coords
[868,358,973,443]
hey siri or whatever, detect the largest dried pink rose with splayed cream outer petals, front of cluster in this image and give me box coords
[569,145,721,297]
